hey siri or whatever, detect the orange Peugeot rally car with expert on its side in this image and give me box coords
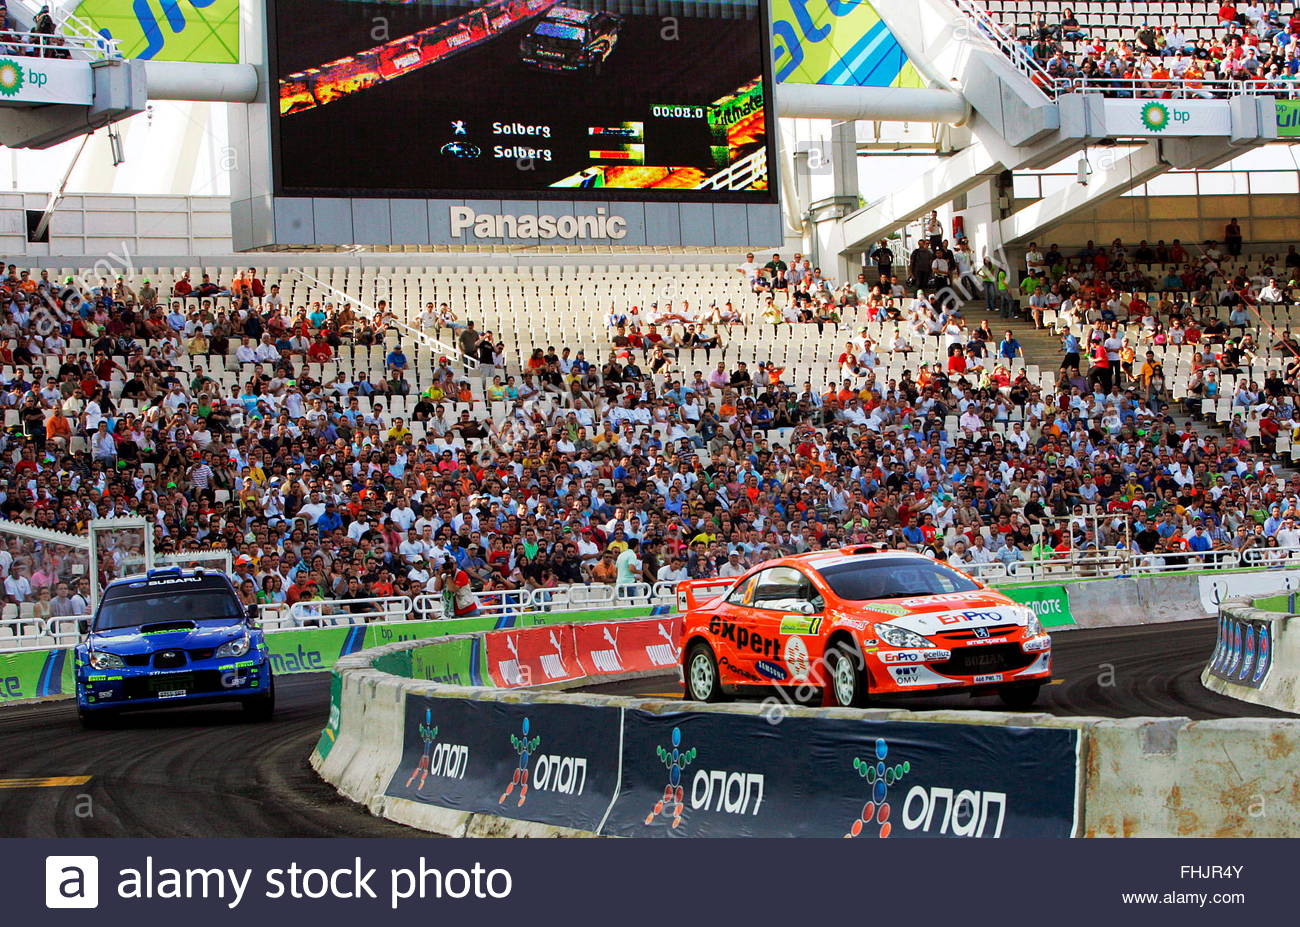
[679,547,1052,707]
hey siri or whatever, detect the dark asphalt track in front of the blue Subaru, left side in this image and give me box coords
[0,673,416,837]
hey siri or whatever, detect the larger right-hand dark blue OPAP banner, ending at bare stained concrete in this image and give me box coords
[603,711,1079,837]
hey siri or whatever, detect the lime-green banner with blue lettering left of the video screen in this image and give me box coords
[77,0,239,64]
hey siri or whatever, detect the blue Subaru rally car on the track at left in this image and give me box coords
[73,567,276,727]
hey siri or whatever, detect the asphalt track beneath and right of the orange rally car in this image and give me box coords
[582,619,1291,720]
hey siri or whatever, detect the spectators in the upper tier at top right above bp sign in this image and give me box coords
[1015,0,1300,99]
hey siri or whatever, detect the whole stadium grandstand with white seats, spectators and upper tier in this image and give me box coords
[0,0,1300,644]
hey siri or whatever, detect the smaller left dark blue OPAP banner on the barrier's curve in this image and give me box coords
[386,696,619,831]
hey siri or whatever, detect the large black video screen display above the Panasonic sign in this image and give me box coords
[269,0,775,203]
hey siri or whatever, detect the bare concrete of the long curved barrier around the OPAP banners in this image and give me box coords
[312,611,1300,837]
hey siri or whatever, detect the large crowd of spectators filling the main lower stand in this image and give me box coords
[0,239,1300,626]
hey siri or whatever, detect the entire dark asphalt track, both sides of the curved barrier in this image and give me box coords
[0,620,1286,837]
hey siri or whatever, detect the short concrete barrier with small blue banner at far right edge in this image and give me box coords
[1201,599,1300,715]
